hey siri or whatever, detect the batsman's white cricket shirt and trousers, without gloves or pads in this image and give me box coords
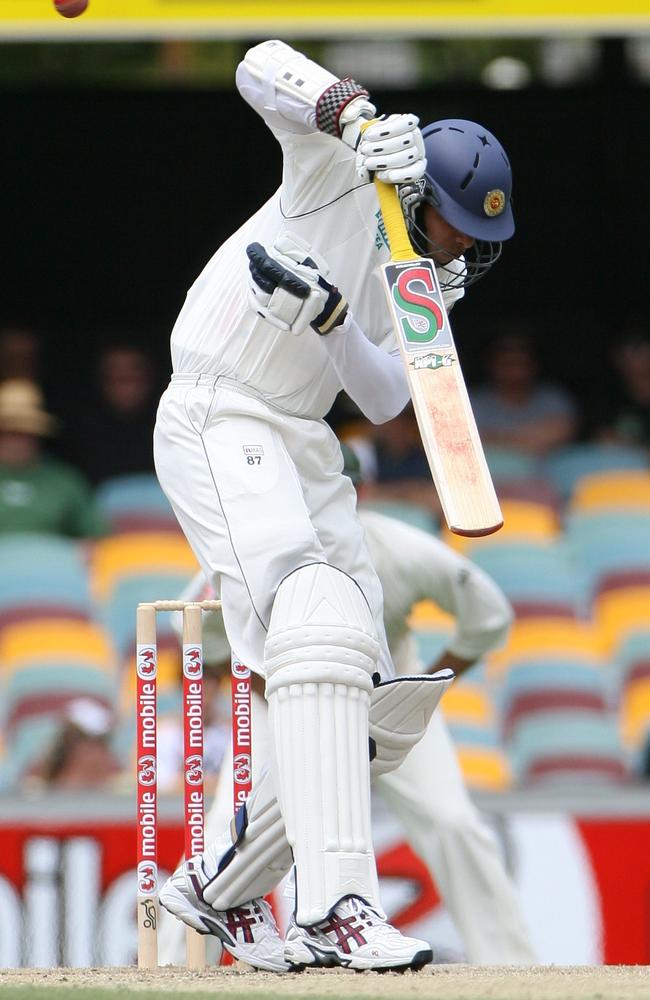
[154,41,462,678]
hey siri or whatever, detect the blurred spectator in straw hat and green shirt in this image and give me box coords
[0,379,106,538]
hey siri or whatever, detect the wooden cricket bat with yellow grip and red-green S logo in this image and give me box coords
[375,178,503,536]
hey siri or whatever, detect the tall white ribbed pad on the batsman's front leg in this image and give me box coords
[265,563,380,926]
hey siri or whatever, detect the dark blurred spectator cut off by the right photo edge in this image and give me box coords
[595,321,650,450]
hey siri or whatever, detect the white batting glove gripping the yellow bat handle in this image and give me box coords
[356,115,427,184]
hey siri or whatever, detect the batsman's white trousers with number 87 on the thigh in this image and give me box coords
[154,375,394,680]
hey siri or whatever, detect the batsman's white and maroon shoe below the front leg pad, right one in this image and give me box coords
[284,896,433,972]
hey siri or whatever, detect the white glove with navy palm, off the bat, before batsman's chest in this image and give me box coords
[246,236,348,336]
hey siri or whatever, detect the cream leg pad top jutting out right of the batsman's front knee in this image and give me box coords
[369,669,454,780]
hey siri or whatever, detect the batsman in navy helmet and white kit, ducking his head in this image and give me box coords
[154,41,514,971]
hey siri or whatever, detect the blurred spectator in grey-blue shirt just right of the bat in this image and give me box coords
[470,332,578,456]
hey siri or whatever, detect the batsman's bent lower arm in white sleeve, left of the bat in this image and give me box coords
[322,314,410,424]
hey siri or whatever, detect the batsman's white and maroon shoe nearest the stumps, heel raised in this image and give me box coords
[159,856,291,972]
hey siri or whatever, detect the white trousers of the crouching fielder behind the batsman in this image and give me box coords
[159,693,536,965]
